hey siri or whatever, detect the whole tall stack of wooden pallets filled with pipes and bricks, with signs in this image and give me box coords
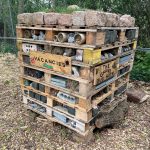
[16,11,138,141]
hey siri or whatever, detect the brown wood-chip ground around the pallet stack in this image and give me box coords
[0,54,150,150]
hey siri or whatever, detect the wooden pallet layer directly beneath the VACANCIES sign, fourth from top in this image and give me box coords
[21,59,133,99]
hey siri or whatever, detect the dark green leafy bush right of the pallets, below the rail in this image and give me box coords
[131,51,150,82]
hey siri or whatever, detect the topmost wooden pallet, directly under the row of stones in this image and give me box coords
[17,26,138,47]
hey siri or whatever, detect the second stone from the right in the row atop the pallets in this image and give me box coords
[106,13,120,27]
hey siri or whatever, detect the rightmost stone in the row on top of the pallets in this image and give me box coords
[119,15,135,27]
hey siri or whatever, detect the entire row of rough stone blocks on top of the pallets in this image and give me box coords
[17,10,135,27]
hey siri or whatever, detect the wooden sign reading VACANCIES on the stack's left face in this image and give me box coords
[30,51,71,74]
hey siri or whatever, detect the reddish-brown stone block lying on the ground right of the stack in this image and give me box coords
[127,88,149,103]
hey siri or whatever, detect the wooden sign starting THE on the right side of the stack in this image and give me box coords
[94,60,117,85]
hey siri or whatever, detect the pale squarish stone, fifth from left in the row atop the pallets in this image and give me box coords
[72,11,85,26]
